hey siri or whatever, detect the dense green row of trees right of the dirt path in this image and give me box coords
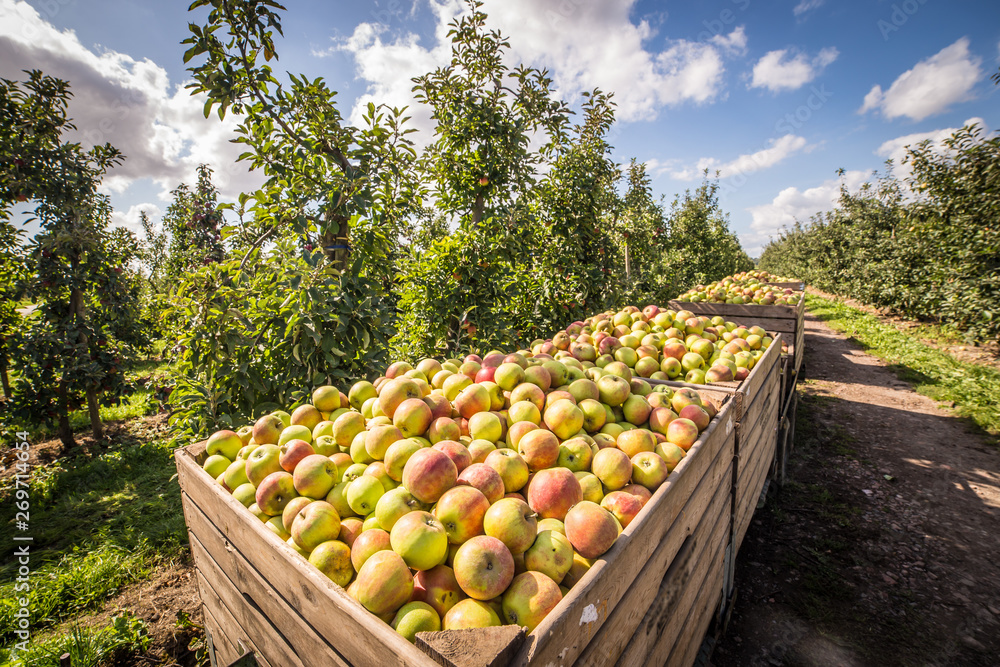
[760,125,1000,341]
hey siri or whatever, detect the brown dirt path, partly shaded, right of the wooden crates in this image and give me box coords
[712,315,1000,667]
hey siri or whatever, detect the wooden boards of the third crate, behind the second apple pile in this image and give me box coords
[668,299,806,404]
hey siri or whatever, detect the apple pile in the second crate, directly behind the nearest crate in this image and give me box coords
[532,305,773,384]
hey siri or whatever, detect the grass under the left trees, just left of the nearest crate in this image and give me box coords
[0,437,186,648]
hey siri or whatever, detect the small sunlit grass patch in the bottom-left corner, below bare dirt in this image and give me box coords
[0,615,150,667]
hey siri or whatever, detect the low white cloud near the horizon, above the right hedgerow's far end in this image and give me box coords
[740,171,871,257]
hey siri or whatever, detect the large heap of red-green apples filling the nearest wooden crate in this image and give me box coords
[203,358,717,641]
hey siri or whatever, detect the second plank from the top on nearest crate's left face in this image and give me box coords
[185,500,348,667]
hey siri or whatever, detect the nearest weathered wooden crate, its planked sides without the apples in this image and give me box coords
[175,400,736,667]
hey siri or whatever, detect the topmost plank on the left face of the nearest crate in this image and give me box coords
[175,449,438,667]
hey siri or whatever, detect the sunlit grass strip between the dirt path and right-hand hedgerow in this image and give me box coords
[806,294,1000,436]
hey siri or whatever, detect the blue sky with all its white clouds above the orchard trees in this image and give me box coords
[0,0,1000,255]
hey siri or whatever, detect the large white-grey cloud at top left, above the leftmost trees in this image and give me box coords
[0,0,262,204]
